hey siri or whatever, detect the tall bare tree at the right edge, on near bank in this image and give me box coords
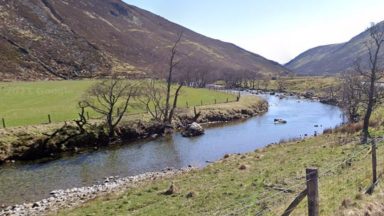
[355,24,384,143]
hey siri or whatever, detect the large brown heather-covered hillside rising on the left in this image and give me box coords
[0,0,289,80]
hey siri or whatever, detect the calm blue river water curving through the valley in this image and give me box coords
[0,95,343,205]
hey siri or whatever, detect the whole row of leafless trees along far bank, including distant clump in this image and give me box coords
[79,32,270,137]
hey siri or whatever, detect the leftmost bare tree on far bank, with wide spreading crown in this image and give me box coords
[81,78,138,137]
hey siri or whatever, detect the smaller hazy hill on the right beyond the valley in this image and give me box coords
[285,22,384,75]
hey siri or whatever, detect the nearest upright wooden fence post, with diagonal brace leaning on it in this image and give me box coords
[306,168,319,216]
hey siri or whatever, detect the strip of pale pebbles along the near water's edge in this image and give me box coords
[0,167,194,216]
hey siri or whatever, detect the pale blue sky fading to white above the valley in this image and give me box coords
[124,0,384,63]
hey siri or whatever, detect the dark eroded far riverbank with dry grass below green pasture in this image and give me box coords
[0,96,268,162]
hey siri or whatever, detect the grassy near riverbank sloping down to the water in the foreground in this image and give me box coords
[54,128,384,215]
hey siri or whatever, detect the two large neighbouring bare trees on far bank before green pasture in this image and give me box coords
[79,32,185,137]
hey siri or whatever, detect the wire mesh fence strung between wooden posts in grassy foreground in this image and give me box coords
[212,140,384,216]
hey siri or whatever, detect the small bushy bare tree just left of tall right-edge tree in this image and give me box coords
[339,71,362,122]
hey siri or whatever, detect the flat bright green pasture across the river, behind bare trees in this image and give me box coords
[0,80,235,127]
